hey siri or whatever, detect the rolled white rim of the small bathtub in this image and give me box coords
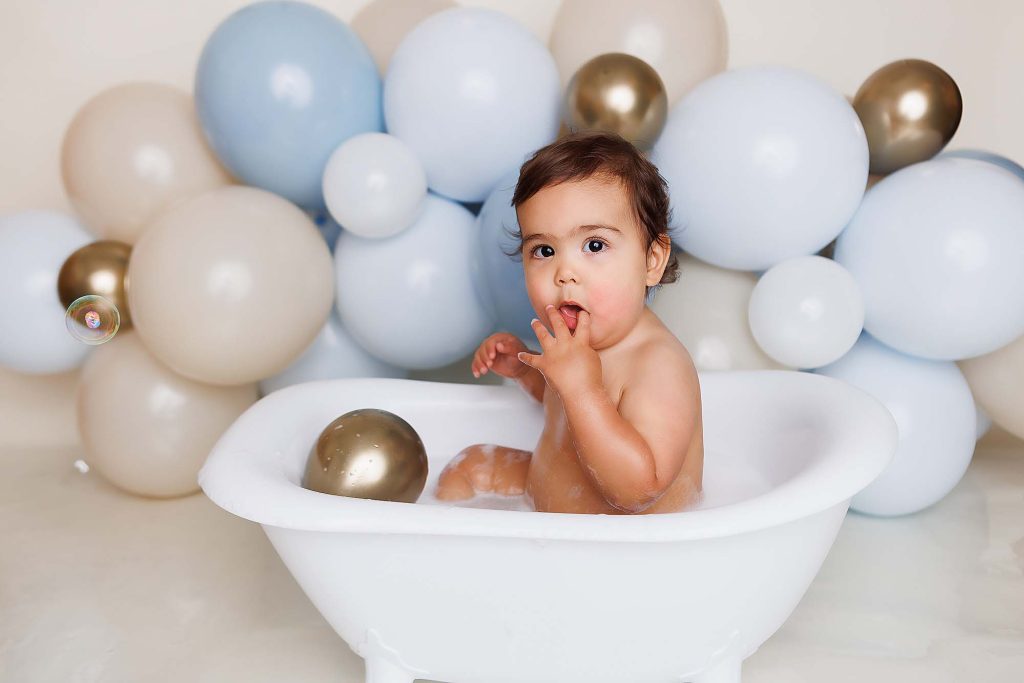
[199,370,898,542]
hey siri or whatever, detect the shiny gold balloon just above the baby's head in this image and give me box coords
[562,52,669,150]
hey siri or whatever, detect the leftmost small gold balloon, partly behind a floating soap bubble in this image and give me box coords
[57,240,131,330]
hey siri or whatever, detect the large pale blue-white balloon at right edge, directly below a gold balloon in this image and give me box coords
[835,157,1024,360]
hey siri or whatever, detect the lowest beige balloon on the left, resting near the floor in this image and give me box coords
[76,332,258,498]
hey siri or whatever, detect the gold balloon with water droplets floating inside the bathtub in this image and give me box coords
[302,409,427,503]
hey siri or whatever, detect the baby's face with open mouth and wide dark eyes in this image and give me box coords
[517,177,668,349]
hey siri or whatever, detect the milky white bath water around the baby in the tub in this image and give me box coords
[417,450,772,512]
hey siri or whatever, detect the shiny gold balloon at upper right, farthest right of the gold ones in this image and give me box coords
[853,59,964,174]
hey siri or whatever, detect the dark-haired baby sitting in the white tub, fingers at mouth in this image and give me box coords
[435,131,703,514]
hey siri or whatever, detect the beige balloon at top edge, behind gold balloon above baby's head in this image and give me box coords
[549,0,729,108]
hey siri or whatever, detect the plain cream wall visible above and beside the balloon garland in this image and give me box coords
[0,0,1024,446]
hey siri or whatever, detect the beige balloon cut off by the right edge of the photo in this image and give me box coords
[956,337,1024,438]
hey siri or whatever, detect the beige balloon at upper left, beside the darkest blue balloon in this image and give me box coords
[60,83,232,244]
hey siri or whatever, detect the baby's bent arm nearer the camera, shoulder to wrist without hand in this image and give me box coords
[562,349,700,513]
